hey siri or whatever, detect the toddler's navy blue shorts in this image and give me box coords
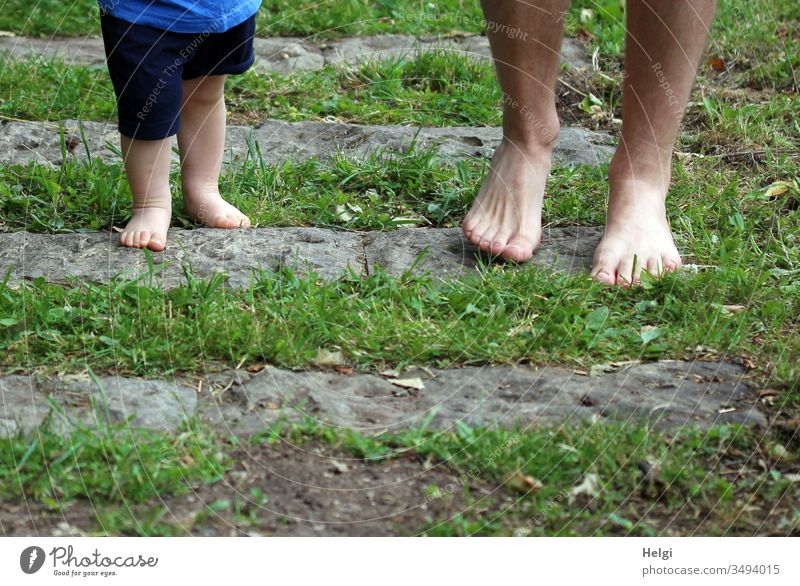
[100,14,256,140]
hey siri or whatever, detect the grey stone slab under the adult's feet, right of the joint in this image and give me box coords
[364,226,603,278]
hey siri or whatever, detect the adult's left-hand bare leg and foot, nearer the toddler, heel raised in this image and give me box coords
[463,0,569,261]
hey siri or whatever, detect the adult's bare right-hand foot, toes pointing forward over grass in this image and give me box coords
[592,157,681,286]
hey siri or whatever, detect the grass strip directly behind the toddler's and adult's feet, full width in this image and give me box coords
[0,140,800,238]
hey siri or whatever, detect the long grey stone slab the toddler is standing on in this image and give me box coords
[0,228,363,289]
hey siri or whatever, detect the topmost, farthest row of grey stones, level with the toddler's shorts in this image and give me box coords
[0,35,590,74]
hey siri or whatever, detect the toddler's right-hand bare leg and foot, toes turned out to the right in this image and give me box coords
[178,75,250,228]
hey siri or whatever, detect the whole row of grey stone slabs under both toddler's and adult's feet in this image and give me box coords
[0,227,602,289]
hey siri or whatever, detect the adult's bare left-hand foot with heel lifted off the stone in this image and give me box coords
[462,140,552,262]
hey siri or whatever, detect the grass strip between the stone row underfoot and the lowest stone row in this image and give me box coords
[0,241,800,402]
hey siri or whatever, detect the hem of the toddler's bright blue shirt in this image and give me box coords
[98,0,261,34]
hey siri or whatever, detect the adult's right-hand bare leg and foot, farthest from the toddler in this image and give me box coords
[592,0,716,285]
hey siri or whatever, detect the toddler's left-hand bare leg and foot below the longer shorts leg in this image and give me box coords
[119,135,172,251]
